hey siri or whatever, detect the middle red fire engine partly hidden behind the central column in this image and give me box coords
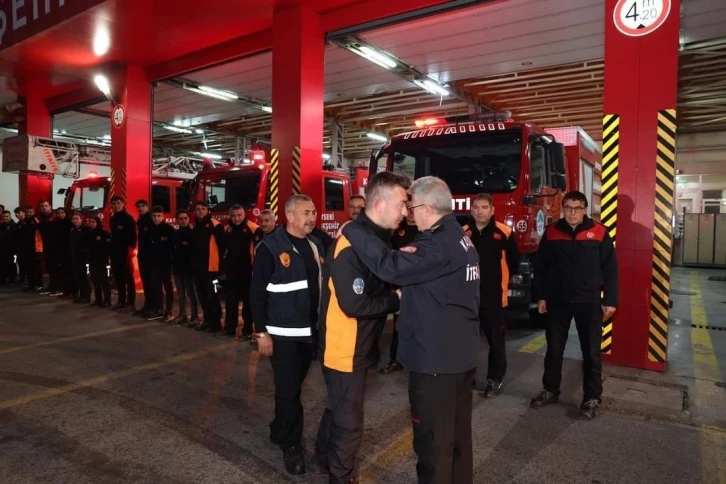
[190,150,368,236]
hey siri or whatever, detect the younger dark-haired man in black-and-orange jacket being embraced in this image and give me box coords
[313,171,410,484]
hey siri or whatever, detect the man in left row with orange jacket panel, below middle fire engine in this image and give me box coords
[192,201,224,333]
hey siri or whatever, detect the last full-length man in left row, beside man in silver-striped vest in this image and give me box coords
[225,205,263,341]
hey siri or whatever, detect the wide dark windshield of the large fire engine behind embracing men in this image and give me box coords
[391,131,522,195]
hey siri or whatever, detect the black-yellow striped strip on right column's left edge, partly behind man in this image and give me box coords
[600,114,620,354]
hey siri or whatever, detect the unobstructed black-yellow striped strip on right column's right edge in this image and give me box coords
[648,109,676,363]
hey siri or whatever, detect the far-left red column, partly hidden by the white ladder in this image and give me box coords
[18,86,53,207]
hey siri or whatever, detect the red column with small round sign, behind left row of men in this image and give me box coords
[111,65,153,217]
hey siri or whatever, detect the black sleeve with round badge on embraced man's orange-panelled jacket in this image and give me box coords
[330,249,399,319]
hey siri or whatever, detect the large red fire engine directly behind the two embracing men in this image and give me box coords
[369,112,602,315]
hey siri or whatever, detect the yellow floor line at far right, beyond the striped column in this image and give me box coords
[690,271,726,484]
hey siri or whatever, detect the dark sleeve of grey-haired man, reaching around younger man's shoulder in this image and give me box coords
[343,224,450,286]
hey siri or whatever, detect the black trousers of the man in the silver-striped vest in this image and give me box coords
[268,336,313,450]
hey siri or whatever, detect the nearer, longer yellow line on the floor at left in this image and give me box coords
[0,342,236,410]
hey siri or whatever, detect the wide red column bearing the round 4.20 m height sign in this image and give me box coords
[604,0,680,371]
